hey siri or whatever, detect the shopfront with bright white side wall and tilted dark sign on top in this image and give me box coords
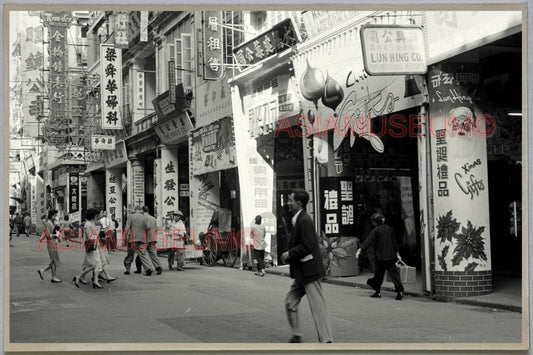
[231,19,304,263]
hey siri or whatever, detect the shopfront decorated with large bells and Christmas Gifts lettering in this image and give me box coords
[292,17,424,275]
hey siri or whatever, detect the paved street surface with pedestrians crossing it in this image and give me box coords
[9,235,522,343]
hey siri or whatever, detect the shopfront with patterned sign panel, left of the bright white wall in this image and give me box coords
[188,68,236,241]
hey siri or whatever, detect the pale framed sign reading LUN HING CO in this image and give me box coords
[361,25,427,75]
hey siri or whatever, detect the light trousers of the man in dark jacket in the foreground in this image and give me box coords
[285,280,333,343]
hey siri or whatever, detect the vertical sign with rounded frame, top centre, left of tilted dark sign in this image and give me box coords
[202,11,224,80]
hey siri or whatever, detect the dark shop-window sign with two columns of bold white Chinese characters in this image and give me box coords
[320,177,354,237]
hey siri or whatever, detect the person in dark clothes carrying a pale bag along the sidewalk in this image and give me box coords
[355,213,404,300]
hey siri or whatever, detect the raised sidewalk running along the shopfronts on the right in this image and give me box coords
[266,265,522,312]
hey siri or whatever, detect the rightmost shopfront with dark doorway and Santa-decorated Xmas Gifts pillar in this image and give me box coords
[425,11,524,300]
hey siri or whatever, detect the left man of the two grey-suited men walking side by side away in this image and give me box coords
[124,206,154,276]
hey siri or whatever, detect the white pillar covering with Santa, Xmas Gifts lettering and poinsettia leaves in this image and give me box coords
[429,69,491,271]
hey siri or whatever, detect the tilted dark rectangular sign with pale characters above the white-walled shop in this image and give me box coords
[233,18,301,71]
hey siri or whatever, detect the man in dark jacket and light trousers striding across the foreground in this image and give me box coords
[281,189,333,343]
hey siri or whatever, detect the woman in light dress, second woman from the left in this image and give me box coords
[72,209,103,288]
